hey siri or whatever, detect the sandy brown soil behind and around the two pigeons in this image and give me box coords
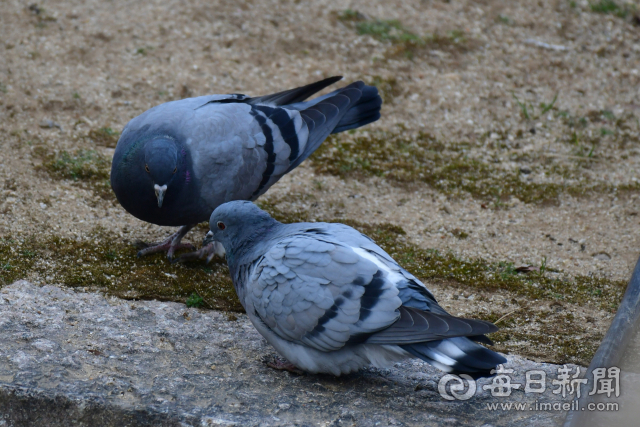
[0,0,640,363]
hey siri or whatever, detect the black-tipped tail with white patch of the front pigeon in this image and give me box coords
[400,337,507,375]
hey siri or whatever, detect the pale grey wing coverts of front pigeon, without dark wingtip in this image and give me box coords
[246,230,401,351]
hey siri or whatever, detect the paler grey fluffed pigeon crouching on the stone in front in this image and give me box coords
[205,201,506,376]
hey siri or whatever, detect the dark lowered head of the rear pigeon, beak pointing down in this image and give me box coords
[144,138,178,208]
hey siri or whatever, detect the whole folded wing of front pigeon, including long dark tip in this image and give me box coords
[247,228,497,360]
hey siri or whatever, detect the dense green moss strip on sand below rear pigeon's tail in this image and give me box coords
[311,132,563,205]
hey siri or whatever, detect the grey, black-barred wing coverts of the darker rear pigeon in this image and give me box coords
[183,102,309,207]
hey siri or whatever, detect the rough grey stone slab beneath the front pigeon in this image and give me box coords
[0,281,569,427]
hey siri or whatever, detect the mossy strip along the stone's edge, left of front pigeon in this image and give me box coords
[0,230,242,311]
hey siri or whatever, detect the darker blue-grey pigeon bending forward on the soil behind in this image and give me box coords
[111,76,382,262]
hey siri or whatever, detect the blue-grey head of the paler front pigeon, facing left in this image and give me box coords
[203,200,280,258]
